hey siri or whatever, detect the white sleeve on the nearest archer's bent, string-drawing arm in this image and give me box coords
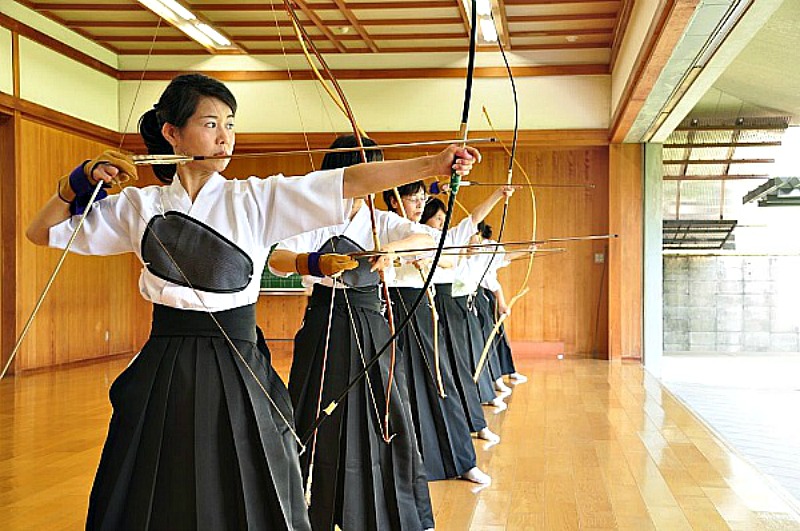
[48,195,135,256]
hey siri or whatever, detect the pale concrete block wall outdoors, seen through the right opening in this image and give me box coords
[663,255,800,352]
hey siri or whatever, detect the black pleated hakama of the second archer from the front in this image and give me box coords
[289,284,433,531]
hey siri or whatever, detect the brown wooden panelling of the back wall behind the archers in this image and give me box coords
[226,144,609,357]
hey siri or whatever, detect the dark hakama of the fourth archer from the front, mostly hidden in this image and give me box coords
[435,284,486,433]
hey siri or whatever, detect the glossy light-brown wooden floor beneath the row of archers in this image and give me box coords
[0,350,800,531]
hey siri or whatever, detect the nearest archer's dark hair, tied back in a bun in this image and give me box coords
[139,74,236,184]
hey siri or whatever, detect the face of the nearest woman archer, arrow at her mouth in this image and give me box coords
[162,97,236,173]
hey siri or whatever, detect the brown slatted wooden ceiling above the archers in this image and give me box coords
[18,0,633,60]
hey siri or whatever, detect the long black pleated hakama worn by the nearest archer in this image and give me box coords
[86,305,310,531]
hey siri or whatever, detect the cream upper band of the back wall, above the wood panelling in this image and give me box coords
[119,75,611,133]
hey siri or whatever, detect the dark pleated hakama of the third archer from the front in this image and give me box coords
[391,288,476,481]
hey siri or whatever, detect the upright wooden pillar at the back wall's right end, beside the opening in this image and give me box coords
[608,144,644,358]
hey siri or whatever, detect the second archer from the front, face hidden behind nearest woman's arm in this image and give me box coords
[269,135,435,531]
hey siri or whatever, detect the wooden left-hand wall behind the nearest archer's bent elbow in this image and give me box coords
[16,119,149,370]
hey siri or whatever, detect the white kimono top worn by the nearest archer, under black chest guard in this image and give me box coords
[49,169,352,311]
